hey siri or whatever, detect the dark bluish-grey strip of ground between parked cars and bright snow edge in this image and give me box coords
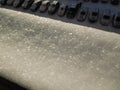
[0,6,120,34]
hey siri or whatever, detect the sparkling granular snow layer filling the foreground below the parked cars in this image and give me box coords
[0,9,120,90]
